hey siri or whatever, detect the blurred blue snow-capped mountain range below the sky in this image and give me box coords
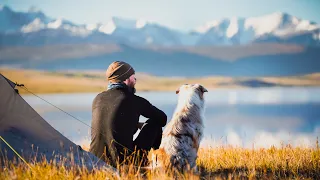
[0,6,320,46]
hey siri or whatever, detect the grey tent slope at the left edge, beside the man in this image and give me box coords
[0,74,115,174]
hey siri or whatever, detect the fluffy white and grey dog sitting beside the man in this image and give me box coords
[152,84,207,170]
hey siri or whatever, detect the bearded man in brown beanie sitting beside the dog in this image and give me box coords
[89,61,167,166]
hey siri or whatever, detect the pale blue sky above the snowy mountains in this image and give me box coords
[0,0,320,31]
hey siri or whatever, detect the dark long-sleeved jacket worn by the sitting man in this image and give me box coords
[89,88,167,165]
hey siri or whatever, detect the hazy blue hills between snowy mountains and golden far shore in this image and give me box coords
[0,44,320,77]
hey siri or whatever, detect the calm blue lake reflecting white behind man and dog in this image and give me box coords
[23,87,320,148]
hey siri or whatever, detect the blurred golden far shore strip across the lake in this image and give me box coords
[0,68,320,94]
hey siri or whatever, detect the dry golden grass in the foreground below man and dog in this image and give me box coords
[0,146,320,179]
